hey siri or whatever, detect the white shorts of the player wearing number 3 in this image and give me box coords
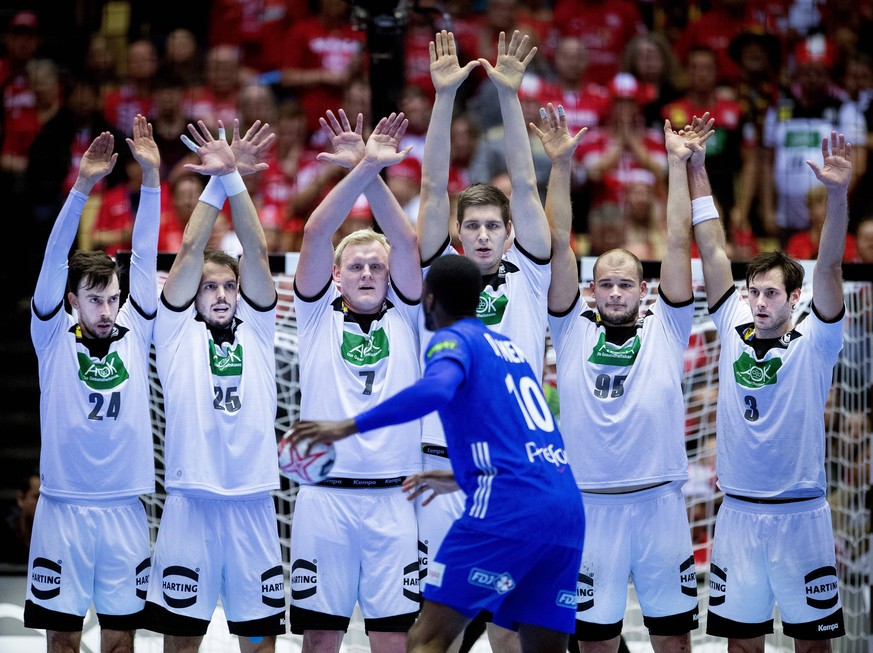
[706,496,844,639]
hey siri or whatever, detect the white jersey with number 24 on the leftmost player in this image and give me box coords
[30,292,155,501]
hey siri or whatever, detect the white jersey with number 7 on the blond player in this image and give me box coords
[294,283,421,479]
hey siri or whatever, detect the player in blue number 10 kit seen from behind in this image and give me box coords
[292,256,585,653]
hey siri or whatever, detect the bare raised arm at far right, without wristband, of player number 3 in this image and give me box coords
[807,132,852,320]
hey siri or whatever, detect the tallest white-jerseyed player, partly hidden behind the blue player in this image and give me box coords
[416,31,551,653]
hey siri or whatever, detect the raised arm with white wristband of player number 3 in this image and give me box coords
[685,113,734,307]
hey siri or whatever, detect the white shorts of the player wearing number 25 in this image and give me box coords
[148,494,285,636]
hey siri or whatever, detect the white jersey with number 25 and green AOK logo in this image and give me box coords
[155,293,279,496]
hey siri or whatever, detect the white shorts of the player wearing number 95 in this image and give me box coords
[576,481,698,641]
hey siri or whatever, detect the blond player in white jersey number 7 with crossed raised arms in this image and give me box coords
[289,110,421,653]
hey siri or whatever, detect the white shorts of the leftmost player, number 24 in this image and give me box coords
[25,494,151,631]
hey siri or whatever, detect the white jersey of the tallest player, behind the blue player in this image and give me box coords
[419,243,552,446]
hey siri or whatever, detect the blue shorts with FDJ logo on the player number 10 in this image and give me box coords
[424,522,582,633]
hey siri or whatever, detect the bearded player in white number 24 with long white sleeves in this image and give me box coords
[24,115,161,652]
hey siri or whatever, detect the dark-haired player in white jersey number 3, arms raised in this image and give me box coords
[689,123,852,653]
